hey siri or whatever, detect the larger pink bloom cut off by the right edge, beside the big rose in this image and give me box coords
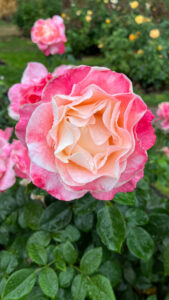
[157,102,169,130]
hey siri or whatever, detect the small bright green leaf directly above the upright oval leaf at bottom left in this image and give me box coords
[28,244,47,265]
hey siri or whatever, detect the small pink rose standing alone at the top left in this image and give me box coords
[31,16,66,56]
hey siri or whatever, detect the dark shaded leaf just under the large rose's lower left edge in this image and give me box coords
[40,201,72,232]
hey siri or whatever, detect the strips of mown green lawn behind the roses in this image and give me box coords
[0,31,169,106]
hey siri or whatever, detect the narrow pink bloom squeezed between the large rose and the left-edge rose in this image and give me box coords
[11,140,31,182]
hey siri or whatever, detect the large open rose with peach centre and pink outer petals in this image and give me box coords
[16,66,155,201]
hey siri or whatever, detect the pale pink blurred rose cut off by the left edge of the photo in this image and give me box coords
[0,128,15,193]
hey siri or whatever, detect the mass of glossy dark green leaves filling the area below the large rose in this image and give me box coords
[0,125,169,300]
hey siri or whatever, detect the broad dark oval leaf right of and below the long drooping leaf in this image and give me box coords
[127,227,154,260]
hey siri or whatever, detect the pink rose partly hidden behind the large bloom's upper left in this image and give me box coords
[8,62,72,120]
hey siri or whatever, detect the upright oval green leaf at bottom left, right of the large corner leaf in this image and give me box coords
[39,267,58,298]
